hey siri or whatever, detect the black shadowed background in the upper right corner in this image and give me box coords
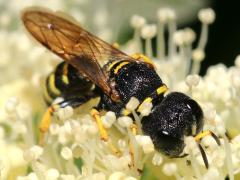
[190,0,240,75]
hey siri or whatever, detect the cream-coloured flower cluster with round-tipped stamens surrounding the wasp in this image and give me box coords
[0,4,240,180]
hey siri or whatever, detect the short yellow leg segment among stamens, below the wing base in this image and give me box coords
[91,109,108,141]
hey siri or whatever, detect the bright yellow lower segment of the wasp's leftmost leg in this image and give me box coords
[39,106,55,145]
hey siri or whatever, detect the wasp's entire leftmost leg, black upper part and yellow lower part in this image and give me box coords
[39,95,95,145]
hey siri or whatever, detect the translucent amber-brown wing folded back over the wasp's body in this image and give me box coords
[22,9,136,100]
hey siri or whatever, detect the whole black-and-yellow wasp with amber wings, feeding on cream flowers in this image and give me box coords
[22,9,220,167]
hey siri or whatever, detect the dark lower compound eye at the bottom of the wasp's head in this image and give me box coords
[153,131,184,157]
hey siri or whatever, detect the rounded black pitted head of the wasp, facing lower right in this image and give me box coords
[142,92,203,157]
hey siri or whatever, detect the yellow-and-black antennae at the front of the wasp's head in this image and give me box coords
[194,130,221,169]
